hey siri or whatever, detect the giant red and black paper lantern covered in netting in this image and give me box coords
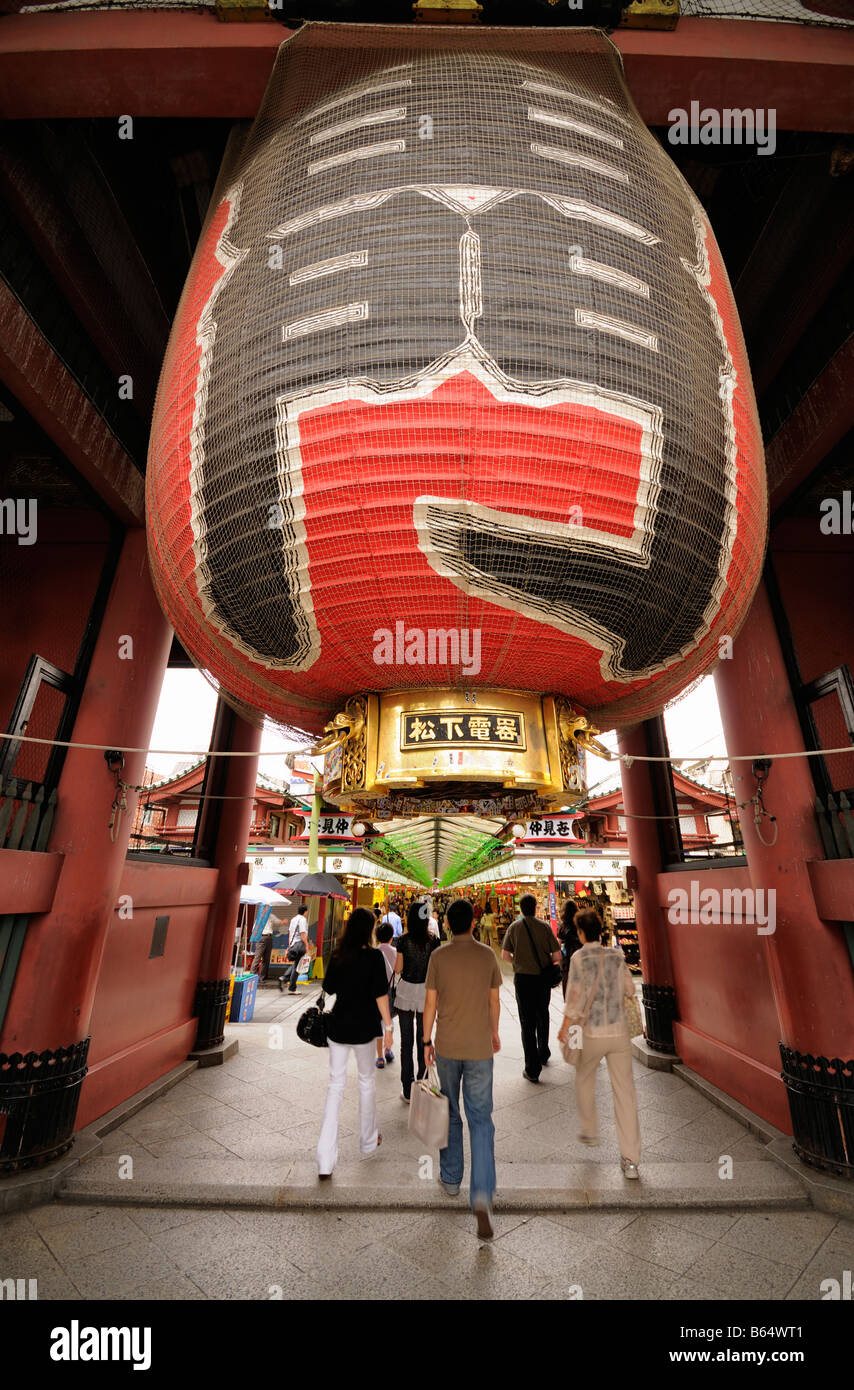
[147,25,766,730]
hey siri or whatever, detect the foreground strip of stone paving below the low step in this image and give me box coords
[0,1198,854,1301]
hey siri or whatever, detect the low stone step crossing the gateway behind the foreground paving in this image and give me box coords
[58,1155,809,1212]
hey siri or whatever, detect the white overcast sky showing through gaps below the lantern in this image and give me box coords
[146,670,726,785]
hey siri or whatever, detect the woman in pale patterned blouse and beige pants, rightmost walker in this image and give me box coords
[558,912,640,1177]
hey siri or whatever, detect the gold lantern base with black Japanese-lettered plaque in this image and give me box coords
[314,688,605,820]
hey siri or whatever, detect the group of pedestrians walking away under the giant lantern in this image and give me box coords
[317,894,640,1238]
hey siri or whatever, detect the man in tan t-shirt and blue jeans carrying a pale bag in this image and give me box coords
[424,898,501,1240]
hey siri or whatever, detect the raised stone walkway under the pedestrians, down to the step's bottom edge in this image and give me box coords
[63,970,807,1211]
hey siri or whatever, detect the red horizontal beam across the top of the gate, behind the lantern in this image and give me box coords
[0,10,854,132]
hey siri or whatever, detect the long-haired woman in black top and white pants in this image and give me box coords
[317,908,394,1177]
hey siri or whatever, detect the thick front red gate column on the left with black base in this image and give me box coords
[0,528,172,1165]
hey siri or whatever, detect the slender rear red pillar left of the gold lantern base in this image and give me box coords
[192,703,263,1056]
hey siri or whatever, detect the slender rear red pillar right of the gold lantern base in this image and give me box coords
[618,724,676,1052]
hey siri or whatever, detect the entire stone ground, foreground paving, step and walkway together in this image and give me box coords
[0,961,854,1301]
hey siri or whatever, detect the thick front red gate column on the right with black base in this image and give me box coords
[715,584,854,1177]
